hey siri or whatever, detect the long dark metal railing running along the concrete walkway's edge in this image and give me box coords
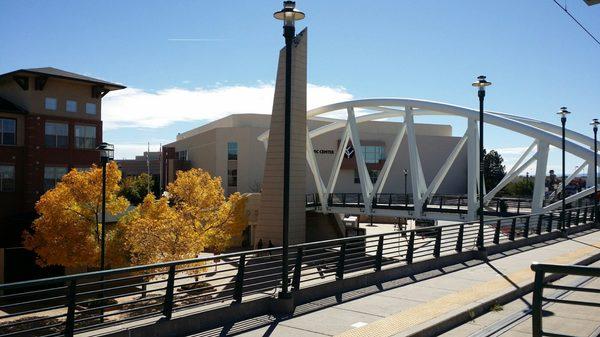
[0,206,593,337]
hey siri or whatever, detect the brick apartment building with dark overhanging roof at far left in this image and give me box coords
[0,68,125,283]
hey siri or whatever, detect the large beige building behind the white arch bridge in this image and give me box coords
[165,114,467,198]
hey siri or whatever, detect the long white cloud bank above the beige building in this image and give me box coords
[102,84,352,130]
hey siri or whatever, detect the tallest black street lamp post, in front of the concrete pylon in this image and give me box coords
[273,1,304,297]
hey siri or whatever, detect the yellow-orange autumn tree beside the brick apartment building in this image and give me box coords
[23,162,129,267]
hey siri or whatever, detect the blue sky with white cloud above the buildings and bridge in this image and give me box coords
[0,0,600,170]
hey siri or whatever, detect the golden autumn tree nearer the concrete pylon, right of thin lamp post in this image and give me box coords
[119,169,247,264]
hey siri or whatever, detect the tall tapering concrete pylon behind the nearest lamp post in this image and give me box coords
[255,28,307,246]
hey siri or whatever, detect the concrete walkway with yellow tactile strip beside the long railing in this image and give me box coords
[193,231,600,337]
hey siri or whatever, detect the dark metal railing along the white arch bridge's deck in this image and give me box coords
[305,193,591,216]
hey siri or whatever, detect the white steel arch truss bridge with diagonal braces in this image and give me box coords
[259,98,594,220]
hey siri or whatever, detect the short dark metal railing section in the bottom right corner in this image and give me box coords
[531,263,600,337]
